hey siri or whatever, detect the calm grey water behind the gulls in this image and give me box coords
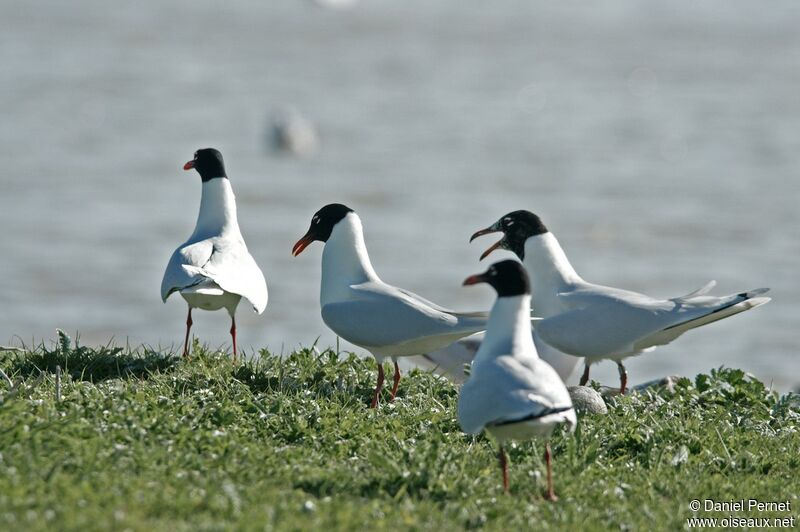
[0,0,800,389]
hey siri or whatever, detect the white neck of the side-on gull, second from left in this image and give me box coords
[320,212,380,305]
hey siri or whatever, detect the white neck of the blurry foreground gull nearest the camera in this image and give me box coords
[475,294,539,361]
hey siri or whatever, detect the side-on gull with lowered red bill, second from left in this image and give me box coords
[292,203,488,408]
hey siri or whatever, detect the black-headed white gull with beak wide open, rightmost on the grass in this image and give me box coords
[470,210,770,393]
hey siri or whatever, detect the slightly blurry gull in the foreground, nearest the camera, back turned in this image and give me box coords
[458,260,577,501]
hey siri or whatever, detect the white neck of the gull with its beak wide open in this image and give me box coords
[522,233,583,318]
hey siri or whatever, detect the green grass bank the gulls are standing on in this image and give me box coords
[0,337,800,532]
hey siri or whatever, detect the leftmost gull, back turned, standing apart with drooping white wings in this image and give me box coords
[161,148,267,363]
